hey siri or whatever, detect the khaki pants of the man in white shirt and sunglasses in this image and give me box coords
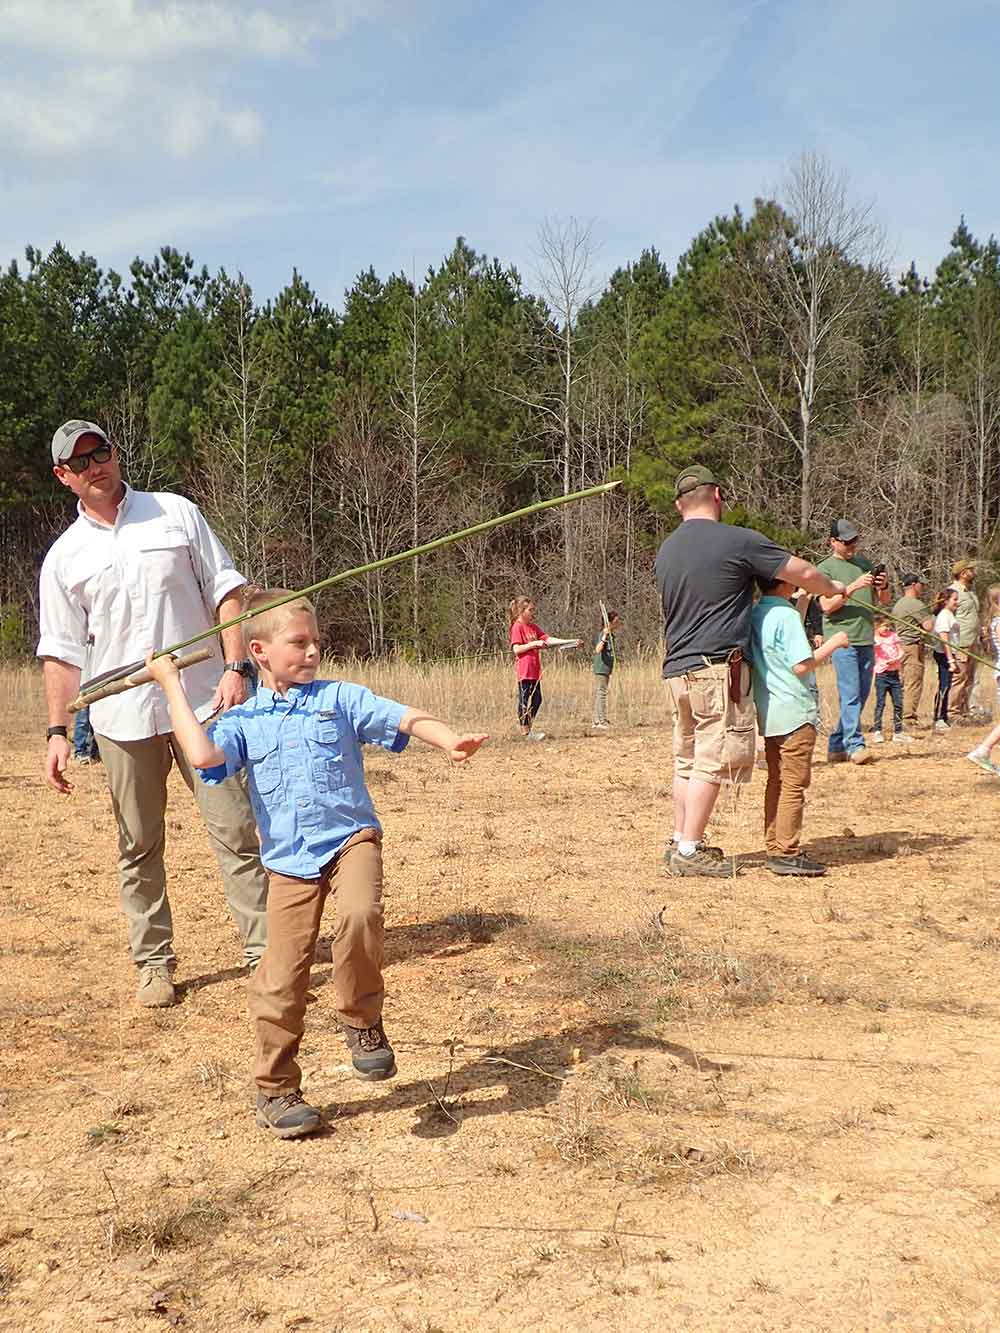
[97,736,268,968]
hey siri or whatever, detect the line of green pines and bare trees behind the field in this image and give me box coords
[0,156,1000,657]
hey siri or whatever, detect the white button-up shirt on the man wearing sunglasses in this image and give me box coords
[36,487,247,741]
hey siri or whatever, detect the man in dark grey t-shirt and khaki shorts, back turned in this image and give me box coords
[656,467,843,878]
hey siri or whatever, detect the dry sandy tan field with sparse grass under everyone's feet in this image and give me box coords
[0,661,1000,1333]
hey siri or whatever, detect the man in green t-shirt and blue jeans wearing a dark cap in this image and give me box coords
[816,519,889,764]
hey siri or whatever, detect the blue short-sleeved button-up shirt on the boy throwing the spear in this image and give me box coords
[199,680,409,880]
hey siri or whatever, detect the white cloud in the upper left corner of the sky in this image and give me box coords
[0,0,377,168]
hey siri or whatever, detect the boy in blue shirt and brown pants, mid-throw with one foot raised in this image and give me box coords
[147,589,488,1138]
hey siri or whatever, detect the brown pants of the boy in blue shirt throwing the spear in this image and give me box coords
[249,829,385,1097]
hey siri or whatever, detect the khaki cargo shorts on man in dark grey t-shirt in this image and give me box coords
[667,661,757,785]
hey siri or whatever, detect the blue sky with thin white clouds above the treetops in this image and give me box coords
[0,0,1000,307]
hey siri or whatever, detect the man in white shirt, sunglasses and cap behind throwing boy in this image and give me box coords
[37,421,267,1006]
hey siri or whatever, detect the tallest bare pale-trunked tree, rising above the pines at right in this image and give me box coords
[728,155,885,528]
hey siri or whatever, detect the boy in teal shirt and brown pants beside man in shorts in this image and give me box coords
[751,579,848,876]
